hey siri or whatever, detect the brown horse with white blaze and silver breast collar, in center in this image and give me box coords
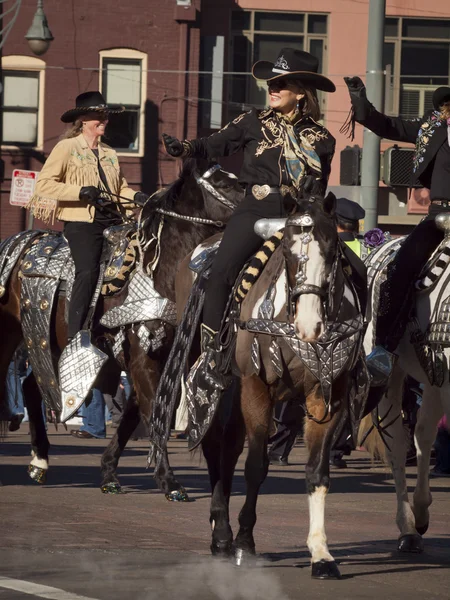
[177,192,363,578]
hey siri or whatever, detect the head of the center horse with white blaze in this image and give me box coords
[283,194,338,342]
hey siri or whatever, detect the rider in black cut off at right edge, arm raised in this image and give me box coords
[344,77,450,384]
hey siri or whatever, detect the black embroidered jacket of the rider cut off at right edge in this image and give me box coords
[352,97,447,188]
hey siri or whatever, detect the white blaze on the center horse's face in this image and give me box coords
[291,240,325,342]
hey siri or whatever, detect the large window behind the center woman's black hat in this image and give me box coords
[228,10,328,119]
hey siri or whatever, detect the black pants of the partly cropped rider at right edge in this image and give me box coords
[376,211,448,352]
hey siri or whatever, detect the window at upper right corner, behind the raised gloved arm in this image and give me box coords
[384,17,450,118]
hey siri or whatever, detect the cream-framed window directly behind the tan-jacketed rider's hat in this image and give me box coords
[100,48,147,156]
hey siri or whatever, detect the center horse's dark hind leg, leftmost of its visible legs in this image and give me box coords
[202,385,245,556]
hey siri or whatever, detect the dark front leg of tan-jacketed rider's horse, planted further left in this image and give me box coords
[100,390,140,494]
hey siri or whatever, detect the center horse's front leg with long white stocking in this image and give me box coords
[305,386,346,579]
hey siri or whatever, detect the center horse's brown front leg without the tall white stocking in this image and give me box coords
[235,375,272,566]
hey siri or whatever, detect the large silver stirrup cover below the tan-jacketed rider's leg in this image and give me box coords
[59,330,108,423]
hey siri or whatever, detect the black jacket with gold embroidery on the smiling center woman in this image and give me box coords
[185,108,336,192]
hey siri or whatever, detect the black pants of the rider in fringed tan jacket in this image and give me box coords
[64,221,107,338]
